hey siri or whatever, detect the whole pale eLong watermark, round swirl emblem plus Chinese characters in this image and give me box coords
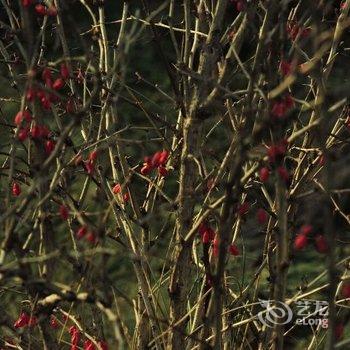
[257,299,328,328]
